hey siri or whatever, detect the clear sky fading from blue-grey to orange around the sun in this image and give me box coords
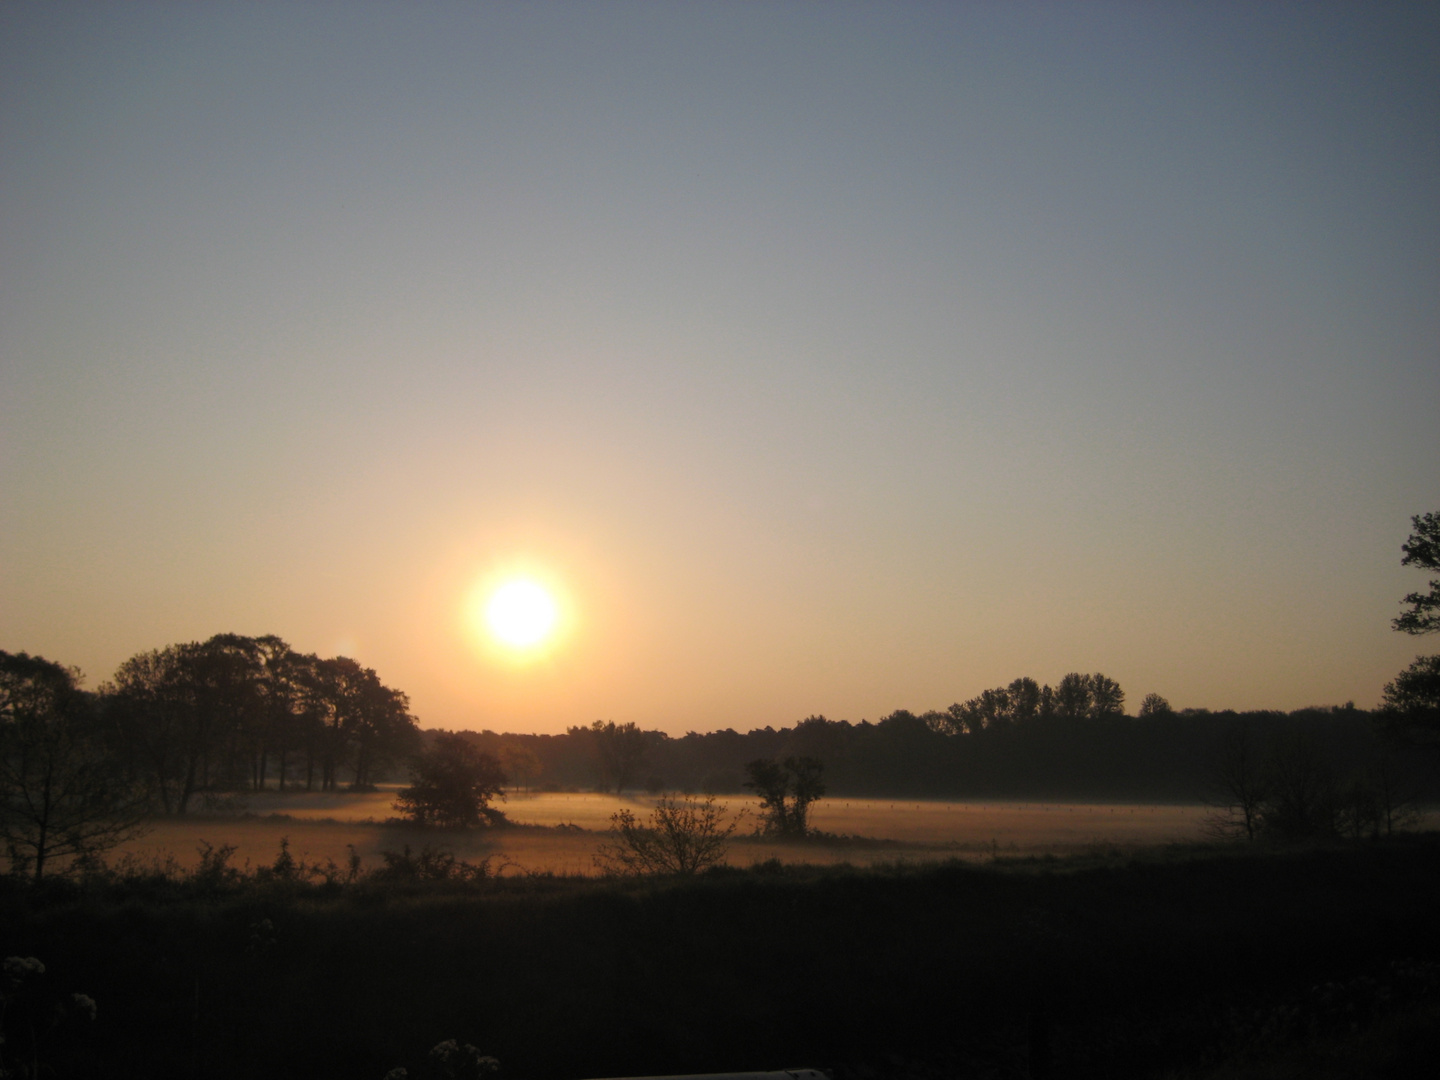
[0,0,1440,734]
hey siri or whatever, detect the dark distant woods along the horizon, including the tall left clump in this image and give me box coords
[22,634,1440,814]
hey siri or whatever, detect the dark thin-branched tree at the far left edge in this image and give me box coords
[0,652,145,881]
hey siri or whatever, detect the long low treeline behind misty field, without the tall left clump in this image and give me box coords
[440,696,1434,802]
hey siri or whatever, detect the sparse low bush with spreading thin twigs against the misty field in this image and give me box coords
[595,795,739,877]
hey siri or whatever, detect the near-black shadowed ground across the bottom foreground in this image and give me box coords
[0,835,1440,1080]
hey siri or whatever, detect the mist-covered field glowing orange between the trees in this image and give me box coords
[120,789,1208,874]
